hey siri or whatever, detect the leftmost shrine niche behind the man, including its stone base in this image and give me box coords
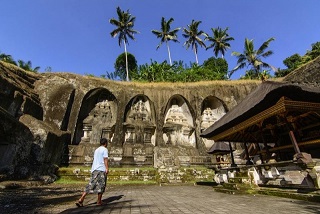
[69,89,117,165]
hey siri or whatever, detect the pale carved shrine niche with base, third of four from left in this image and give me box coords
[154,95,210,167]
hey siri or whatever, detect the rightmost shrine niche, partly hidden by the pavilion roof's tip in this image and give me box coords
[200,96,226,149]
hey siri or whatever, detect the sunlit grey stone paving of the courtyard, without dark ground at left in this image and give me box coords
[60,186,320,214]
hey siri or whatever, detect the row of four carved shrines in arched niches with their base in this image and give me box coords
[69,89,232,167]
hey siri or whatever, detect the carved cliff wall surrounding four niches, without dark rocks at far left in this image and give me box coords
[35,73,260,167]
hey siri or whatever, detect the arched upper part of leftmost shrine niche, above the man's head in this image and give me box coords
[72,88,117,145]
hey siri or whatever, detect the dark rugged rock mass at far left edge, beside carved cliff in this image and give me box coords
[0,61,70,179]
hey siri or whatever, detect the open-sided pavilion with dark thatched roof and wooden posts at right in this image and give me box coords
[201,57,320,187]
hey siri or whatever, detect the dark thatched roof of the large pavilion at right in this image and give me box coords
[201,81,320,138]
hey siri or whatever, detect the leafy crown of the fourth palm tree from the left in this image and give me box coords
[205,27,234,58]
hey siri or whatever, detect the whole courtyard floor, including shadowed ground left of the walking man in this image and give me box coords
[0,185,320,214]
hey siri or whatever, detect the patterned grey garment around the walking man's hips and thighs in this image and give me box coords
[84,170,107,193]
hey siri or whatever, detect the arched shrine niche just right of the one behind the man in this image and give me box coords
[121,95,156,165]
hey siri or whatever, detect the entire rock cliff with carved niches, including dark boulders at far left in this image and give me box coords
[0,62,260,181]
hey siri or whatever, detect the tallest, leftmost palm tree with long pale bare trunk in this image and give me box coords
[109,7,139,81]
